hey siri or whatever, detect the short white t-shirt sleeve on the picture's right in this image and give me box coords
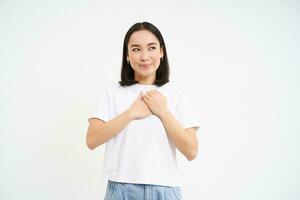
[176,95,200,131]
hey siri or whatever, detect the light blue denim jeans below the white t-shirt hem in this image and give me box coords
[104,180,182,200]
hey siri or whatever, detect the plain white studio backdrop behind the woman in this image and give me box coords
[0,0,300,200]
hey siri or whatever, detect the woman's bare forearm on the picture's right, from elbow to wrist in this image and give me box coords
[160,111,198,160]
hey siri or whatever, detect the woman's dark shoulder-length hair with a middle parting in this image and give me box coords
[119,22,170,86]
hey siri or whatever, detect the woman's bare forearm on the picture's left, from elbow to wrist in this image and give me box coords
[88,110,132,149]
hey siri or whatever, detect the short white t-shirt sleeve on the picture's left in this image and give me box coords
[88,88,109,122]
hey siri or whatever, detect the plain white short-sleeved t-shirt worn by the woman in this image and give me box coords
[89,82,199,187]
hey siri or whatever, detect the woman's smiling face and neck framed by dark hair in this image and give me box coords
[127,30,163,81]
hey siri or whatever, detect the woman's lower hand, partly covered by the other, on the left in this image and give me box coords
[129,92,152,119]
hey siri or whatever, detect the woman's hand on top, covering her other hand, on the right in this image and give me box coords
[143,90,168,118]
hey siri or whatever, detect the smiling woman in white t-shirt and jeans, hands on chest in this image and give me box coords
[87,22,199,200]
